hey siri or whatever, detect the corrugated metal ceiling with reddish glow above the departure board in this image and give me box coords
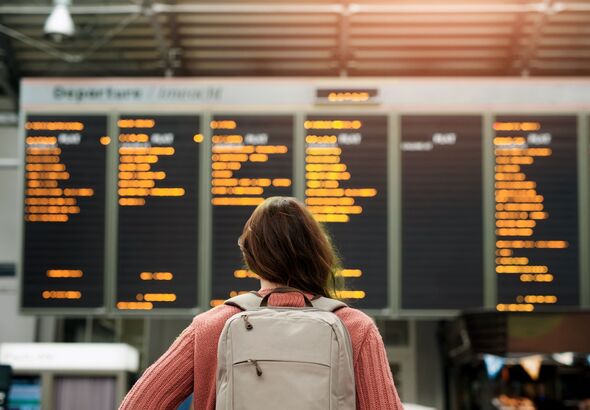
[0,0,590,109]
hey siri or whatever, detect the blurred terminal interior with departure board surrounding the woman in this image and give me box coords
[0,0,590,410]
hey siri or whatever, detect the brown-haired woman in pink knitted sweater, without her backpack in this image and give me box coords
[120,197,403,410]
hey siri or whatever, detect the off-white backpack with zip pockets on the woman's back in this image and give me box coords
[215,288,356,410]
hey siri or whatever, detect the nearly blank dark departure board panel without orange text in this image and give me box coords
[400,115,483,310]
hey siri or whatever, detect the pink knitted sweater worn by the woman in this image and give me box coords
[119,289,403,410]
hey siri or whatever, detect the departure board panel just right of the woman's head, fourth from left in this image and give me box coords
[304,115,388,309]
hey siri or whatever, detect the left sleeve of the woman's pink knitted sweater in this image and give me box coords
[119,325,194,410]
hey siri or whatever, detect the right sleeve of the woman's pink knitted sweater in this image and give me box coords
[355,324,403,410]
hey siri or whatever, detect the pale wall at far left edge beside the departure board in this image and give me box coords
[0,124,35,343]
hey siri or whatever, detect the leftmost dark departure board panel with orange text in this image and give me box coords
[21,115,110,308]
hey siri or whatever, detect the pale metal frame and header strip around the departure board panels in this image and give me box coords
[17,78,590,318]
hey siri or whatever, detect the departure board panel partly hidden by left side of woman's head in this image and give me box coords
[210,115,294,306]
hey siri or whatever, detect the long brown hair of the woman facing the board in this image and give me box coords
[238,197,340,297]
